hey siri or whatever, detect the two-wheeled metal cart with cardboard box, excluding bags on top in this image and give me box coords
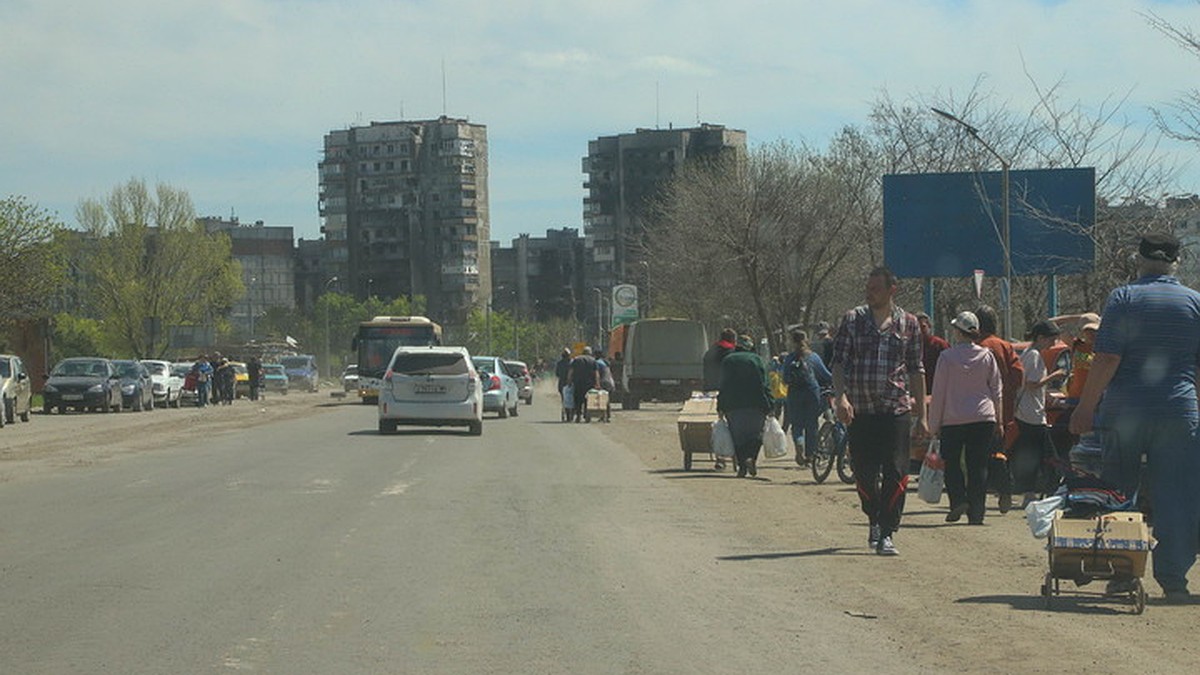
[1042,512,1151,614]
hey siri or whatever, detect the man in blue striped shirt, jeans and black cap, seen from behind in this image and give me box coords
[1070,234,1200,603]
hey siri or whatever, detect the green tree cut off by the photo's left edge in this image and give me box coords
[0,197,66,322]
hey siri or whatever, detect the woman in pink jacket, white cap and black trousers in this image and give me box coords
[929,312,1001,525]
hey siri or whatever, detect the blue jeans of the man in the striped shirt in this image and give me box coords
[1100,414,1200,591]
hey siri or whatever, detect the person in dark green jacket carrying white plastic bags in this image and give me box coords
[716,335,770,478]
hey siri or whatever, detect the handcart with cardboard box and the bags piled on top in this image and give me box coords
[1025,462,1153,614]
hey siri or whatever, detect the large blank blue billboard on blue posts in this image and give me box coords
[883,168,1096,277]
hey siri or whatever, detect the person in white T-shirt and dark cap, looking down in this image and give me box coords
[1008,321,1066,508]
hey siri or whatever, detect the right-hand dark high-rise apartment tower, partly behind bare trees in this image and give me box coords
[583,124,746,331]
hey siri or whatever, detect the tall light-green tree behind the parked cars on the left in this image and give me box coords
[77,179,245,358]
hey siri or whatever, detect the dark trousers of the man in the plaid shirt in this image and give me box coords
[850,413,912,537]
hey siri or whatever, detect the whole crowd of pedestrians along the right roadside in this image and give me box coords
[703,234,1200,602]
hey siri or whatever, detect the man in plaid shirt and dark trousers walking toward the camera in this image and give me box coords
[829,267,929,555]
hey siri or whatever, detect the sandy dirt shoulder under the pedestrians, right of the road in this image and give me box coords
[600,396,1200,673]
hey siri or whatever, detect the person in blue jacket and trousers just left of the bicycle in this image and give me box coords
[784,330,833,466]
